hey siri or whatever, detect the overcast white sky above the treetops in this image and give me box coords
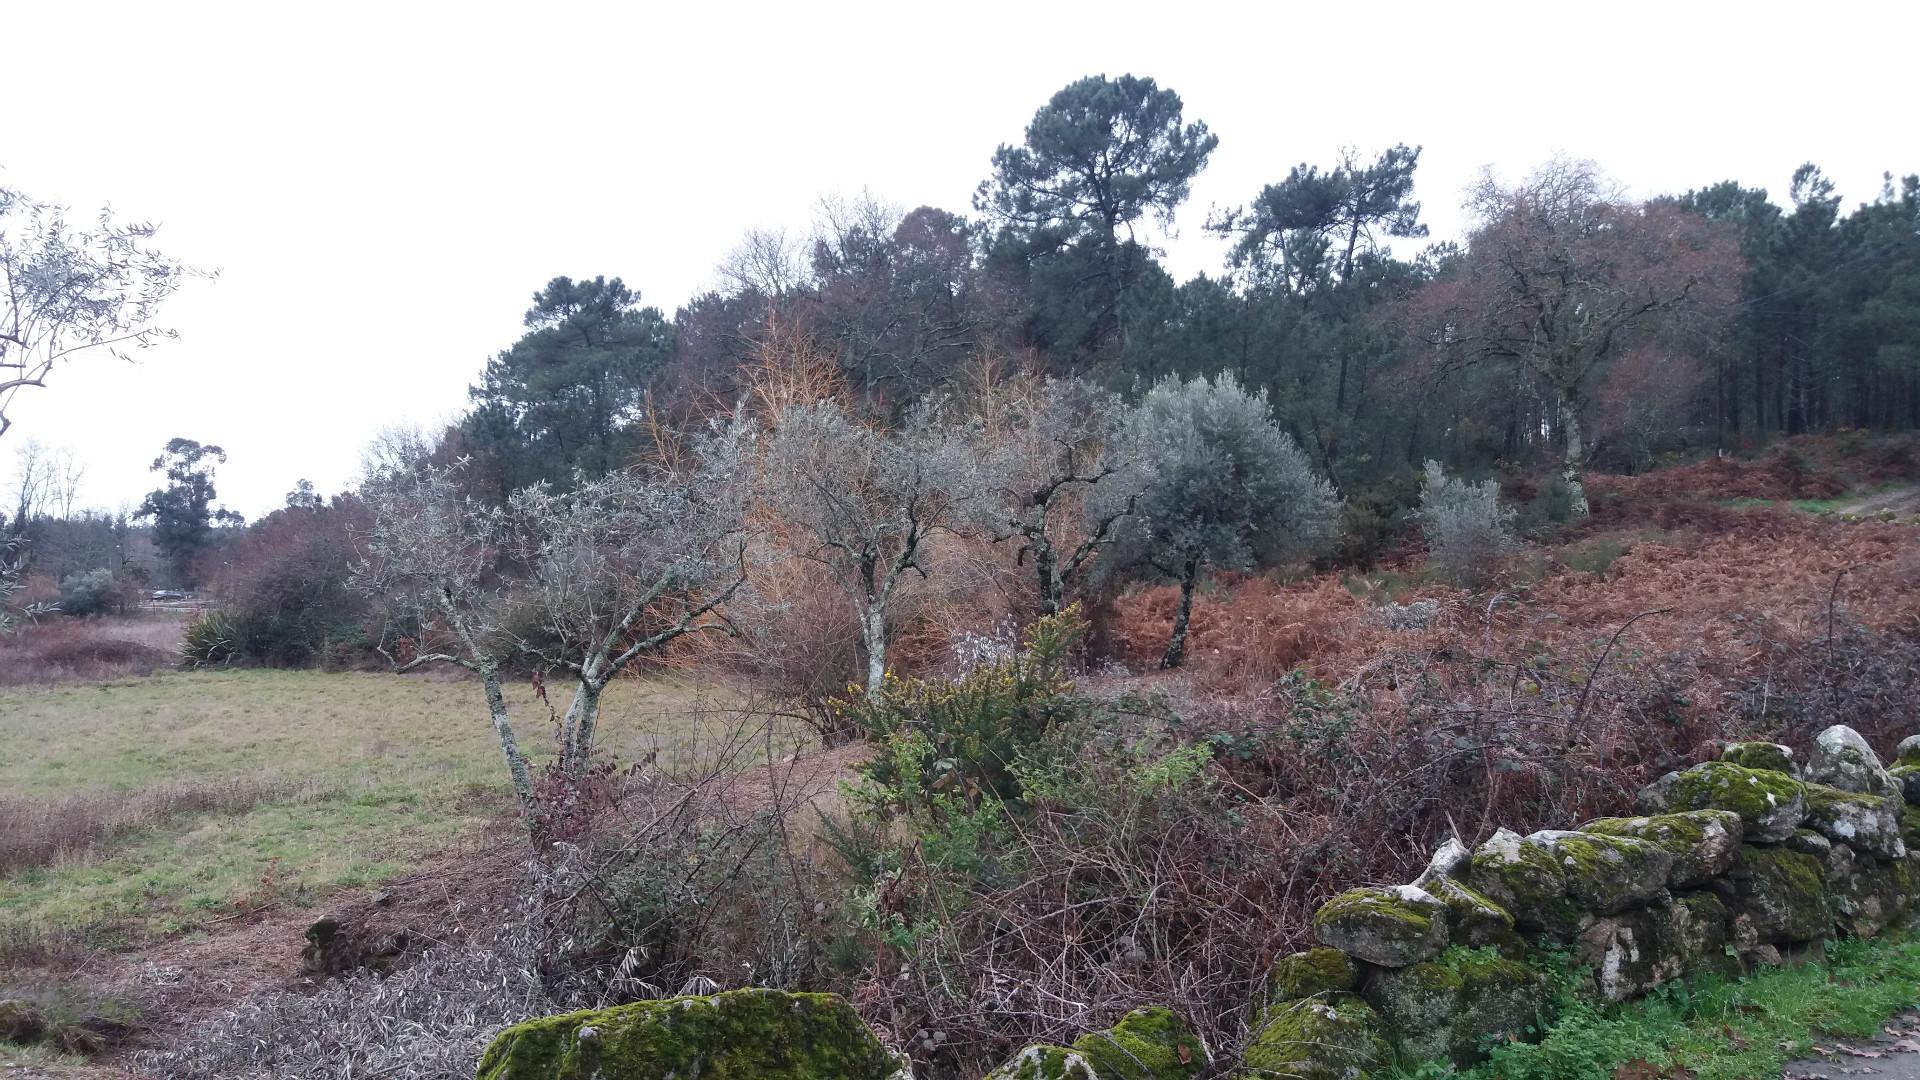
[0,0,1920,517]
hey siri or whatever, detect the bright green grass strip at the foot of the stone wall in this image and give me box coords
[1396,938,1920,1080]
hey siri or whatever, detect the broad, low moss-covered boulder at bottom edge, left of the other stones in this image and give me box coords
[476,990,906,1080]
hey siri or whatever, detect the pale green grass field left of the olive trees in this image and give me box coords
[0,671,764,959]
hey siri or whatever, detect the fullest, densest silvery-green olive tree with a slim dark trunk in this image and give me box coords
[1127,373,1338,667]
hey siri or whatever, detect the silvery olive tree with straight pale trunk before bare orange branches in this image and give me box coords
[760,400,979,694]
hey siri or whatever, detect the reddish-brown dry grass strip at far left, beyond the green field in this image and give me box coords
[0,613,182,686]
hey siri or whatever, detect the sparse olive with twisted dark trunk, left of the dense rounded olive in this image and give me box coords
[977,379,1148,615]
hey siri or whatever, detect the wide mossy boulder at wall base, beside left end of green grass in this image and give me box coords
[1361,947,1551,1067]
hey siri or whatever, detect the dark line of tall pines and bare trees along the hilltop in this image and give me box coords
[447,75,1920,503]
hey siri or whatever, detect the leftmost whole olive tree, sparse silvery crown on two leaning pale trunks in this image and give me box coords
[355,419,753,814]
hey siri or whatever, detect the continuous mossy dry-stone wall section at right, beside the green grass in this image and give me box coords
[1246,726,1920,1080]
